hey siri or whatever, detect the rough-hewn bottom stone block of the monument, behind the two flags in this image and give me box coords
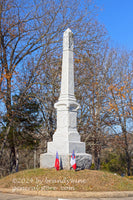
[40,153,92,170]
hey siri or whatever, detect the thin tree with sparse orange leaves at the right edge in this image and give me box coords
[107,50,133,175]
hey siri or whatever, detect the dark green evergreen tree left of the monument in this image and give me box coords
[4,95,42,172]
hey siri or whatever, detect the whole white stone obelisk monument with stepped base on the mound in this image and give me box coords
[40,28,92,169]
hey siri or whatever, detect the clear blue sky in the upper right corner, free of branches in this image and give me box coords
[96,0,133,50]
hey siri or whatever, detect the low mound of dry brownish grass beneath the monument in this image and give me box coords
[0,169,133,192]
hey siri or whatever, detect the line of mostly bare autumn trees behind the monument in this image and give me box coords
[0,0,133,175]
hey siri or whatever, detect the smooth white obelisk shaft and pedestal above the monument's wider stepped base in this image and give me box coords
[53,29,80,148]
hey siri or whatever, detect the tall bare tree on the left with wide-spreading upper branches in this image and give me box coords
[0,0,107,170]
